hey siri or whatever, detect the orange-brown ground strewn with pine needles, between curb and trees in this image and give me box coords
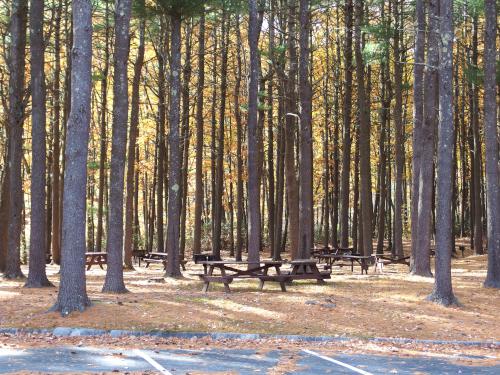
[0,242,500,341]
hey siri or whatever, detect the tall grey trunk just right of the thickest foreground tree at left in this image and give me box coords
[103,0,132,293]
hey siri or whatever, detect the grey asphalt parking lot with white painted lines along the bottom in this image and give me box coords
[0,346,500,375]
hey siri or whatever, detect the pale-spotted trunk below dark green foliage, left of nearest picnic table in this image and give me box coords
[165,15,182,277]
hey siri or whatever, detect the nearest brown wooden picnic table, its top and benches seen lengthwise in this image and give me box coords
[198,260,288,293]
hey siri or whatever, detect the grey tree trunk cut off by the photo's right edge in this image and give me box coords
[483,0,500,288]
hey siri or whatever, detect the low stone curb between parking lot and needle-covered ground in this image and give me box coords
[0,327,500,347]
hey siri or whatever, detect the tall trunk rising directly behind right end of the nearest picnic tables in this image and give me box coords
[298,0,314,259]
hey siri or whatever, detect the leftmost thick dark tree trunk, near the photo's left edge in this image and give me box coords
[4,0,28,279]
